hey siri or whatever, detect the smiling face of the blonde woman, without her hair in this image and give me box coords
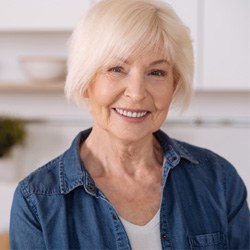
[86,49,175,141]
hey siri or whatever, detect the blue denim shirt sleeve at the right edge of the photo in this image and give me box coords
[226,162,250,249]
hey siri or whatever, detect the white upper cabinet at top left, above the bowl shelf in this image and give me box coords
[0,0,94,31]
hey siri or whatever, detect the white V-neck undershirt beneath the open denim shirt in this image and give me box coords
[120,210,162,250]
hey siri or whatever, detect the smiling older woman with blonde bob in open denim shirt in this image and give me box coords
[10,0,249,250]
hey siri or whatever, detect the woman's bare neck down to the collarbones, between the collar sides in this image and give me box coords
[81,128,162,178]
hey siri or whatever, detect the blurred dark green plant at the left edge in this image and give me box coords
[0,117,26,158]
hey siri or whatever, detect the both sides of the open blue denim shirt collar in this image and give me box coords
[59,128,198,195]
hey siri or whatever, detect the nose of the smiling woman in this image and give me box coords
[124,75,147,102]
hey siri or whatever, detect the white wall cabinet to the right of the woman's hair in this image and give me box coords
[165,0,250,91]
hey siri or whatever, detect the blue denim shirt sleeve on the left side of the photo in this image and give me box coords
[10,184,46,249]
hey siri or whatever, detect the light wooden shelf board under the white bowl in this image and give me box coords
[0,82,64,94]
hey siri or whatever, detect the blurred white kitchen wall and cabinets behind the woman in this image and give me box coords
[0,0,250,246]
